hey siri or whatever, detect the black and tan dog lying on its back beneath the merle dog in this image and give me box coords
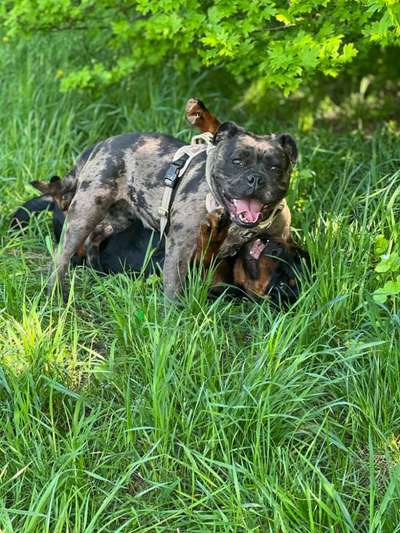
[11,99,309,303]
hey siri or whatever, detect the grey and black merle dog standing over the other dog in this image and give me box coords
[35,110,297,298]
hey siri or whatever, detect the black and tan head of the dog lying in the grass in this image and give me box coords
[234,239,309,303]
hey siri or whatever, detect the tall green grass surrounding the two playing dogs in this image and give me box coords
[0,41,400,533]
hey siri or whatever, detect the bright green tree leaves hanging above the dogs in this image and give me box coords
[0,0,400,94]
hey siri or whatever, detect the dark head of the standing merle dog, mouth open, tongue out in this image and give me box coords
[211,122,297,227]
